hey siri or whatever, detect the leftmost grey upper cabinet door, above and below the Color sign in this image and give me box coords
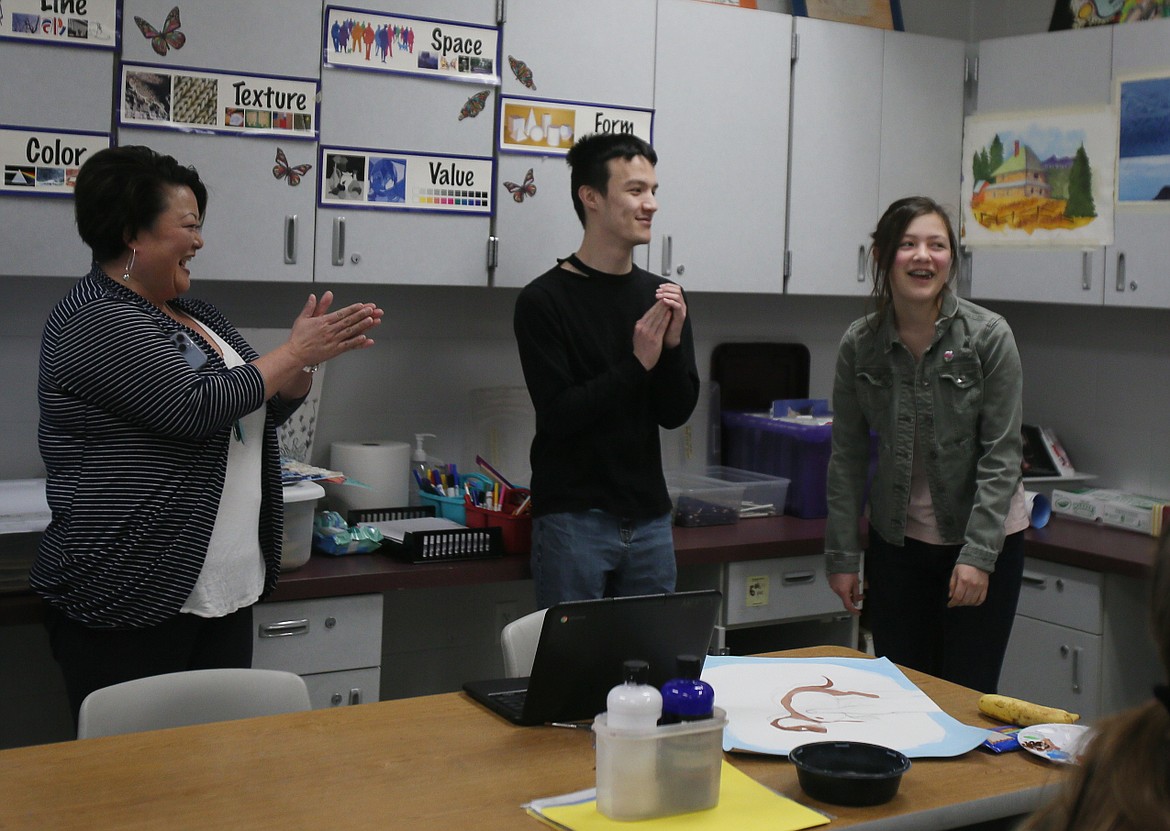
[0,40,113,277]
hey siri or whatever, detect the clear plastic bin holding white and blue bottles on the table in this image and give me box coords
[593,707,728,820]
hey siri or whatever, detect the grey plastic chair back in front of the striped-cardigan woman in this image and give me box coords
[77,668,311,739]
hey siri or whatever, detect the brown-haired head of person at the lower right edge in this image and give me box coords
[1024,534,1170,831]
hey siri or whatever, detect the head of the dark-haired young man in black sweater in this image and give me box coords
[565,133,658,258]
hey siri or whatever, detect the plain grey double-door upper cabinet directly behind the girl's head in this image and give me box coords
[787,18,965,295]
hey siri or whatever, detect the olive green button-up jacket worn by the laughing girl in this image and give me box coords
[825,290,1023,574]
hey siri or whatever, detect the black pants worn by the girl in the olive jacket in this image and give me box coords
[866,527,1024,693]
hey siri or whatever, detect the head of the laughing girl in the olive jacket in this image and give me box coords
[869,197,958,322]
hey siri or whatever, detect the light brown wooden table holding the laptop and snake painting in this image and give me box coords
[0,647,1062,831]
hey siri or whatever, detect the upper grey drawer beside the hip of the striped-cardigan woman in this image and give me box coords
[252,595,381,675]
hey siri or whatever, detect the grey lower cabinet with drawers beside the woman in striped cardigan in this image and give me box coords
[252,595,383,708]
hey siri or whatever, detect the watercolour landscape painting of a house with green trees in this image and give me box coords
[961,108,1117,247]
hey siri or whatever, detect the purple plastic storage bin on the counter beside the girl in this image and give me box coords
[723,412,833,518]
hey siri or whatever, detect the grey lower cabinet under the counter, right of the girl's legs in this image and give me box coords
[999,558,1158,721]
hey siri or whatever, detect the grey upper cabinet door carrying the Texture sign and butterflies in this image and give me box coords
[116,0,321,282]
